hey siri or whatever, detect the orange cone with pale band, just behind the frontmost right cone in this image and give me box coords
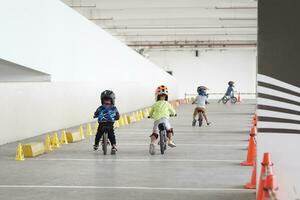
[257,152,273,200]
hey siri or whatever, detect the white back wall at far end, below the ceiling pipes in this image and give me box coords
[148,49,256,98]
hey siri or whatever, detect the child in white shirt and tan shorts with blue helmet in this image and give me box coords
[192,86,210,126]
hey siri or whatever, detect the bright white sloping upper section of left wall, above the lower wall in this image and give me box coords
[0,0,171,81]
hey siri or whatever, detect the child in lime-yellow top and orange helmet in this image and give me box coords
[149,85,176,155]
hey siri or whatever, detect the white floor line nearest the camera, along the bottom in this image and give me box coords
[0,185,249,192]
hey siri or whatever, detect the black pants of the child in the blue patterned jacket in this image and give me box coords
[95,122,116,145]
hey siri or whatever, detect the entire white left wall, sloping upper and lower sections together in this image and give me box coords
[0,0,177,144]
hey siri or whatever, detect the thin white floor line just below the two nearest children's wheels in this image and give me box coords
[30,158,242,163]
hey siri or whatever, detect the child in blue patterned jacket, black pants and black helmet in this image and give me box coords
[94,90,120,154]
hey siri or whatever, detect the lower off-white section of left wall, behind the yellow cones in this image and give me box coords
[0,78,176,144]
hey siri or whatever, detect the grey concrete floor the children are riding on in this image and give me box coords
[0,102,255,200]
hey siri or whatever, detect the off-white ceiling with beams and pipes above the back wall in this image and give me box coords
[63,0,257,49]
